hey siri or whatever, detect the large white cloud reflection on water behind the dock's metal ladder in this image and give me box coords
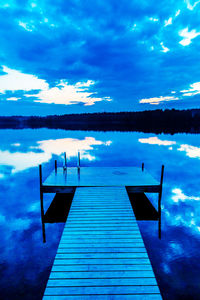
[0,137,111,173]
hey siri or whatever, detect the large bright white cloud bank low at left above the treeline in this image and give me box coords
[0,66,111,105]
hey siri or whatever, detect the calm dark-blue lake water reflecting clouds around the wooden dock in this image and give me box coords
[0,129,200,300]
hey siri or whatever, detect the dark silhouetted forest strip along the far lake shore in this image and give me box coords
[0,109,200,134]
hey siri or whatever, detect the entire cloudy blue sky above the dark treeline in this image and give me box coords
[0,0,200,115]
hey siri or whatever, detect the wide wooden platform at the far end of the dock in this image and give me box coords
[42,167,160,192]
